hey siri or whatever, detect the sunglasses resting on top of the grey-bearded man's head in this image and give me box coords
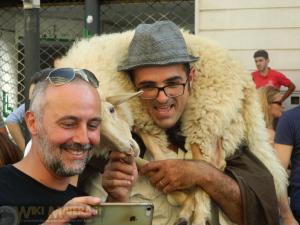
[46,68,99,88]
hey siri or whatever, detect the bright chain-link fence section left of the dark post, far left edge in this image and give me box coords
[0,3,24,117]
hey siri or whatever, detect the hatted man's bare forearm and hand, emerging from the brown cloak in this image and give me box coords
[140,159,243,224]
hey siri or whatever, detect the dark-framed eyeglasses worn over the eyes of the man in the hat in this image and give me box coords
[138,79,188,99]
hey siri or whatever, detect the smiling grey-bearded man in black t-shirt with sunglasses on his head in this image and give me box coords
[0,68,108,224]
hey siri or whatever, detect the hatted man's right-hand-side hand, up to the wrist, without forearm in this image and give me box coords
[140,159,201,193]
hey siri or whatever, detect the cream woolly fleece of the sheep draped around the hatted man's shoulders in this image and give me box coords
[58,31,287,223]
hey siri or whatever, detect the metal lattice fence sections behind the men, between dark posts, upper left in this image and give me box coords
[0,0,194,117]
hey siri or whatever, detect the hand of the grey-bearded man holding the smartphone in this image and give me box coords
[43,196,100,225]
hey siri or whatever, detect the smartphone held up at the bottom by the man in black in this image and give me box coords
[86,203,154,225]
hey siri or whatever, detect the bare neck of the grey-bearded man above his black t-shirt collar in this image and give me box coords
[14,148,71,191]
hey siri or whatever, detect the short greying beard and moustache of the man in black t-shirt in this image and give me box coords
[37,124,93,177]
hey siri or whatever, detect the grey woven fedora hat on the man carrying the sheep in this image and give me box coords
[118,21,199,71]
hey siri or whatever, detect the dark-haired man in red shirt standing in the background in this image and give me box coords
[252,50,296,102]
